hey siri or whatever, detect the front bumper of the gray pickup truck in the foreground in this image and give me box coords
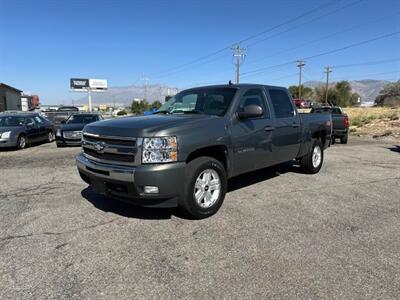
[76,154,186,207]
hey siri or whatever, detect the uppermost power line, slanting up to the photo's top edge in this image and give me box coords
[148,1,335,77]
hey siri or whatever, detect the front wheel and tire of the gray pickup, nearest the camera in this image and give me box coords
[179,156,227,219]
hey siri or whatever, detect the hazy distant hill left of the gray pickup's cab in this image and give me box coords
[75,84,179,106]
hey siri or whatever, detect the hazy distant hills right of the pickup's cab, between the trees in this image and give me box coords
[304,79,389,106]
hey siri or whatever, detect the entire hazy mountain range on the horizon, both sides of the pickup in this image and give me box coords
[75,79,389,106]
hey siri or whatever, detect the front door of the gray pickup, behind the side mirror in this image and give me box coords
[231,88,273,175]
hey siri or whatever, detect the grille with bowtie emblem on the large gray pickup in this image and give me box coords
[82,133,140,166]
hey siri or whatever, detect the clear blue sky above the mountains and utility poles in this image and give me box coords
[0,0,400,104]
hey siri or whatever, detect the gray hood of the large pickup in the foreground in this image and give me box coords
[84,115,221,137]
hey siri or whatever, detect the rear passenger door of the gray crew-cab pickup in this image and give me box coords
[267,87,301,163]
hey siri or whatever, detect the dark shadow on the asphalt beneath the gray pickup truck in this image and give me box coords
[81,163,299,220]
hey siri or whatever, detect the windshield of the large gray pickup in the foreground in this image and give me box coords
[155,88,237,116]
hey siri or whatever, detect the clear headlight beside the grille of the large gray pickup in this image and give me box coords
[142,136,178,164]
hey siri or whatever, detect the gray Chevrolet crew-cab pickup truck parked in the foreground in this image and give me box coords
[76,84,332,219]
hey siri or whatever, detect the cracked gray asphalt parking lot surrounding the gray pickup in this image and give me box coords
[0,139,400,299]
